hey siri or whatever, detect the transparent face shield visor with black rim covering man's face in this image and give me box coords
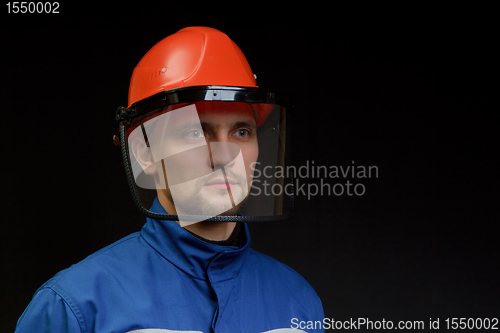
[117,86,294,226]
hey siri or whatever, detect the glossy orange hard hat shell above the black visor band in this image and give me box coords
[128,27,257,107]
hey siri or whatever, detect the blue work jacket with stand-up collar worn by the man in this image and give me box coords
[16,200,324,333]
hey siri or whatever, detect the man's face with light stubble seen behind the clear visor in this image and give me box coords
[148,102,259,216]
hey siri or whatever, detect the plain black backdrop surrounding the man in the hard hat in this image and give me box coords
[0,2,500,332]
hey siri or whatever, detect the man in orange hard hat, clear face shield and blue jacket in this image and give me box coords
[16,27,323,333]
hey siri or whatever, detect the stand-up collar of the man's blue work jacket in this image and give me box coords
[141,198,250,283]
